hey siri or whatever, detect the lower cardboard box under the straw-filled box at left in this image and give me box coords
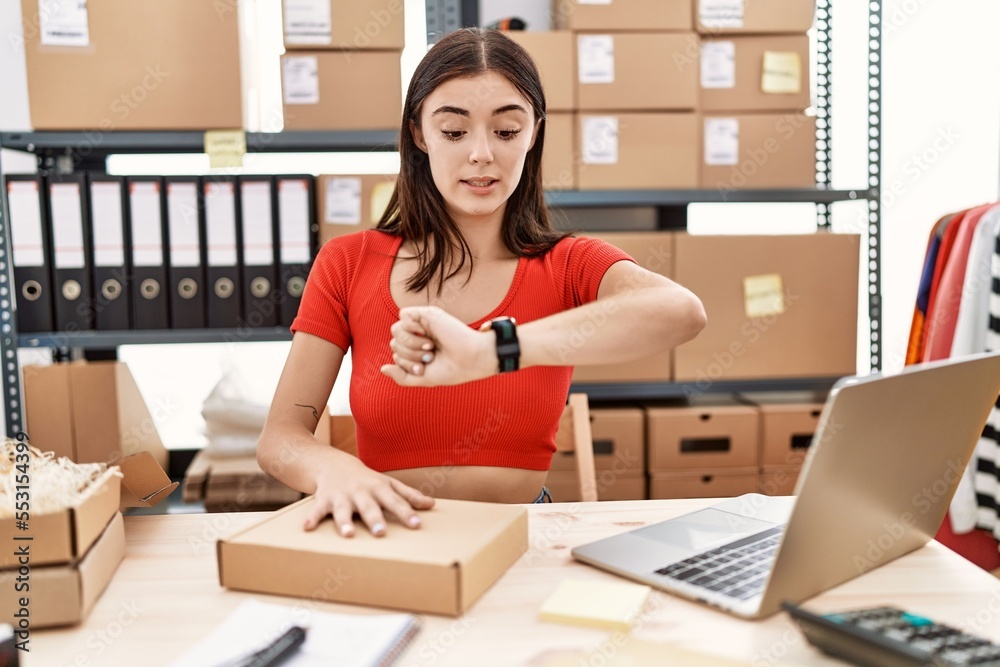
[0,513,125,630]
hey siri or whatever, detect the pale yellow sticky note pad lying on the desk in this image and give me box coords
[538,579,651,630]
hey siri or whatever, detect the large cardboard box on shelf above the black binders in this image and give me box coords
[21,0,243,131]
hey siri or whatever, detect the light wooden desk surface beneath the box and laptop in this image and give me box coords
[29,500,1000,667]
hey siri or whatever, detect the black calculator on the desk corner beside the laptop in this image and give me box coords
[782,602,1000,667]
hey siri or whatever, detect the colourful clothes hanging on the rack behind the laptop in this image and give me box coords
[906,203,1000,569]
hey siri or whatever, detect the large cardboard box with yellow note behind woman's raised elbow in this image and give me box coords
[674,232,860,380]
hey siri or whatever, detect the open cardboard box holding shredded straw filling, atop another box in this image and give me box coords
[0,470,121,568]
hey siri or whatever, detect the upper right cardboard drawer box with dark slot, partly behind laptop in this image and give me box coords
[758,403,823,467]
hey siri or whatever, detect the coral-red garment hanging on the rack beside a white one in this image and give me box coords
[923,204,994,361]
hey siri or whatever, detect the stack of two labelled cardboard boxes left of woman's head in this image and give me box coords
[281,0,404,130]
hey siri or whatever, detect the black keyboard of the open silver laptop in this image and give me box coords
[656,526,784,600]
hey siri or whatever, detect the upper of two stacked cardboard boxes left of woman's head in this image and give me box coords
[282,0,405,51]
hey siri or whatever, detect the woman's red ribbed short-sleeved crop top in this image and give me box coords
[291,230,631,471]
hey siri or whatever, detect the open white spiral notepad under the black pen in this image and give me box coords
[170,600,417,667]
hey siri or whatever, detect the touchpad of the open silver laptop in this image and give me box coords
[633,508,777,557]
